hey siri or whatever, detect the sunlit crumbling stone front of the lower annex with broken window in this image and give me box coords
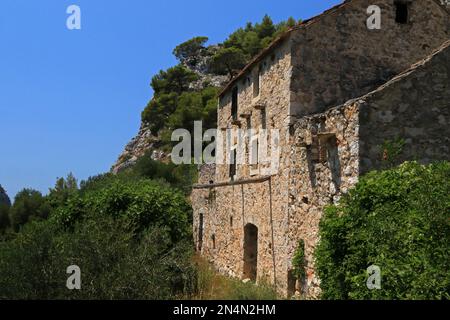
[286,103,359,298]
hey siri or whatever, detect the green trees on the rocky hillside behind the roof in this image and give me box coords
[141,15,297,139]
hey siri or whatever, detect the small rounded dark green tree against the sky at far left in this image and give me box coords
[9,189,51,231]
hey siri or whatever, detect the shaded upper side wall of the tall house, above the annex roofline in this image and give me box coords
[290,0,450,115]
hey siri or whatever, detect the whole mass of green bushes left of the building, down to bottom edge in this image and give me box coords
[0,173,195,299]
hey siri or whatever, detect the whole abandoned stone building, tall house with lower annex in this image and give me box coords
[192,0,450,298]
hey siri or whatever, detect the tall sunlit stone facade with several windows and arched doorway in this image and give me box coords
[199,41,291,290]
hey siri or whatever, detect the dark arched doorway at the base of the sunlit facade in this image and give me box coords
[243,223,258,281]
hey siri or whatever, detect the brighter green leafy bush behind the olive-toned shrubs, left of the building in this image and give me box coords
[52,179,192,242]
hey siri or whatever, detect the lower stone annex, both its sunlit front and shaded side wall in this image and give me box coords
[287,42,450,298]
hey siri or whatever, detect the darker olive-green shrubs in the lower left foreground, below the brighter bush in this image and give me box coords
[0,215,192,299]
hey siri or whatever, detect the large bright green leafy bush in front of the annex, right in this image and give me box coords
[316,162,450,299]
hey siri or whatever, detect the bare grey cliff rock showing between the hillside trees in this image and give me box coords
[111,45,229,173]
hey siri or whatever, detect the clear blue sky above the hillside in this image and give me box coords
[0,0,342,197]
